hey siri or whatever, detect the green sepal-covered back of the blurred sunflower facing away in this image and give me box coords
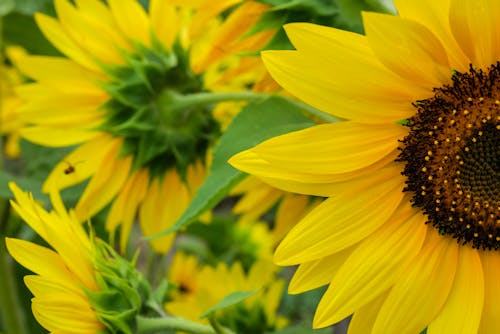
[101,39,220,176]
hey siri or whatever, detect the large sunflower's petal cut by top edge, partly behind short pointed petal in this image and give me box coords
[394,0,470,72]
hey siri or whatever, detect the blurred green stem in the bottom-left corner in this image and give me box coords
[0,224,28,334]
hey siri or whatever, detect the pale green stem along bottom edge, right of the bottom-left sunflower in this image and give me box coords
[137,316,227,334]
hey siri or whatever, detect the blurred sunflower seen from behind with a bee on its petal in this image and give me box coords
[18,0,274,253]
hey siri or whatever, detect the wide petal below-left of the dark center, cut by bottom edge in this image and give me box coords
[372,229,458,334]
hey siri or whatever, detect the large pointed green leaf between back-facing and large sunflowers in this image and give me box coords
[148,96,314,239]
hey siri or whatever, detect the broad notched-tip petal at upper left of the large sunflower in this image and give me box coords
[262,23,431,123]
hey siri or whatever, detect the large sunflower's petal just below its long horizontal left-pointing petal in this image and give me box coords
[275,166,404,265]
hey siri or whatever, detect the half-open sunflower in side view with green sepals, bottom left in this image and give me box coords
[6,183,154,334]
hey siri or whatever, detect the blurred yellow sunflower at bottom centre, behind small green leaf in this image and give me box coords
[165,252,286,333]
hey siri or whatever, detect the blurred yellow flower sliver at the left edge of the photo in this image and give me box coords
[0,46,25,158]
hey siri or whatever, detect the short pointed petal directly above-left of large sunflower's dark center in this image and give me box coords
[363,13,451,89]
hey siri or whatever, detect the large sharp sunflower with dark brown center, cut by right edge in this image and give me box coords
[231,0,500,334]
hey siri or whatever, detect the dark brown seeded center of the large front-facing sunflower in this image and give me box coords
[398,63,500,250]
